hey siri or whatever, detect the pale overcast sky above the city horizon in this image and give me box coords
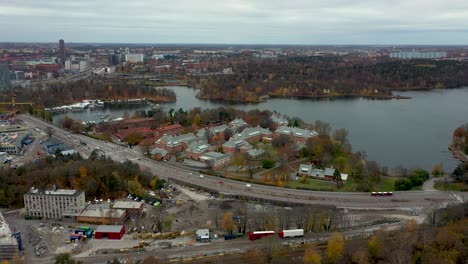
[0,0,468,44]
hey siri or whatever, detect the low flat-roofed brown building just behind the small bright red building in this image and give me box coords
[77,207,127,225]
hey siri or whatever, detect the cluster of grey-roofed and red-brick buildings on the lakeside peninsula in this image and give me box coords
[107,115,318,169]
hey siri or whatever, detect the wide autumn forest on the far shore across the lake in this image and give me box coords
[190,56,468,102]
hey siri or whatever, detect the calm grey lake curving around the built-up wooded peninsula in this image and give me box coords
[54,87,468,169]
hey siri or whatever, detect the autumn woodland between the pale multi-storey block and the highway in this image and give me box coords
[0,151,160,208]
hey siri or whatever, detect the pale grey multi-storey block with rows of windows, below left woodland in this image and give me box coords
[24,187,86,219]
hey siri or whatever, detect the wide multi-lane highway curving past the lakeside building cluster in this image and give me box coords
[19,115,468,211]
